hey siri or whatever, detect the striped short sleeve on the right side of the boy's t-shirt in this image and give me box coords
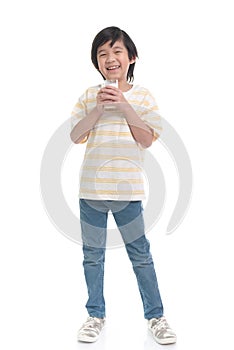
[140,91,162,141]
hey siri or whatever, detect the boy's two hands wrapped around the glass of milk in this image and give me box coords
[97,86,128,110]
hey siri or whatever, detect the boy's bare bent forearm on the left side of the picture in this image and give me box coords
[70,106,102,143]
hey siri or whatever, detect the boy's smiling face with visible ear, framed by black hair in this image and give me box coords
[97,41,135,82]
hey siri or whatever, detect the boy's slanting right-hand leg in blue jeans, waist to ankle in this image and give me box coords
[113,201,163,320]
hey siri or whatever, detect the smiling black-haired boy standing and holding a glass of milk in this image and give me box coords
[71,27,176,344]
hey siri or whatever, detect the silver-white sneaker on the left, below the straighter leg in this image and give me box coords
[77,317,105,343]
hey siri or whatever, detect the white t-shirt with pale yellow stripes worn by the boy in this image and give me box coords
[71,85,161,201]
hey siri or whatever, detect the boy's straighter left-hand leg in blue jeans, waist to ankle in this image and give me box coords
[80,199,108,318]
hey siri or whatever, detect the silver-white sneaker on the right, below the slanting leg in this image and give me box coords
[148,316,176,345]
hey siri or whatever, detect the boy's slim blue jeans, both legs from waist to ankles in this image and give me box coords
[80,199,163,319]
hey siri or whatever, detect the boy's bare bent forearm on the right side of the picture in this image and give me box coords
[124,104,154,148]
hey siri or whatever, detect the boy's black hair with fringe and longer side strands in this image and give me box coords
[91,27,138,82]
